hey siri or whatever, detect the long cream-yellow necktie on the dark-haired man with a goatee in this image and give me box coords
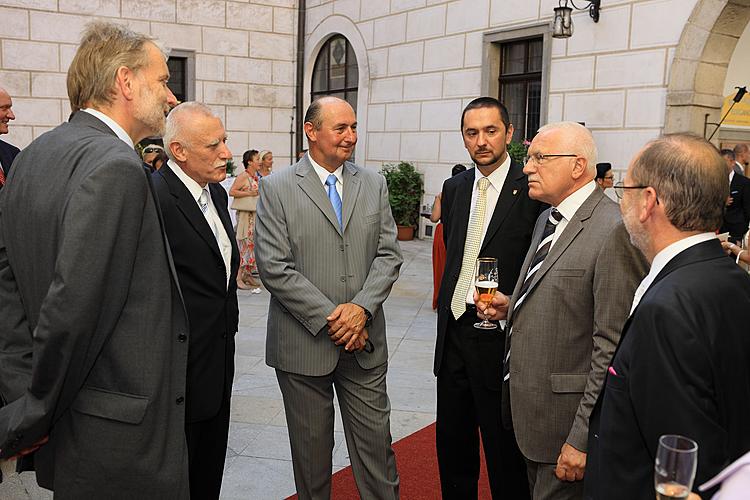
[451,177,490,319]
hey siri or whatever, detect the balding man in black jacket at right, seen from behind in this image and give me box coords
[586,134,750,500]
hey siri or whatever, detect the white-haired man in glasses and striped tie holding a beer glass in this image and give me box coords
[489,122,646,500]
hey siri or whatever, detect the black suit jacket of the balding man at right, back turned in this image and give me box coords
[585,240,750,500]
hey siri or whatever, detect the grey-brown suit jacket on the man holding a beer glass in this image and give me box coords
[503,188,646,463]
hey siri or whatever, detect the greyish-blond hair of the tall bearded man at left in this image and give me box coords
[67,21,167,112]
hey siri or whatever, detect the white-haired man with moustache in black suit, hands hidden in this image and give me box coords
[153,102,239,500]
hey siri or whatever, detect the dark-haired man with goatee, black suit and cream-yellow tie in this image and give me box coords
[434,97,541,499]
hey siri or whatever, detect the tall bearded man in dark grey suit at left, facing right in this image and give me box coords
[0,22,189,500]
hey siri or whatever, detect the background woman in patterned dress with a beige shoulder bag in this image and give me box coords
[229,149,260,293]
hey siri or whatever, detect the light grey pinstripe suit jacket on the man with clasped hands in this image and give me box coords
[255,156,402,376]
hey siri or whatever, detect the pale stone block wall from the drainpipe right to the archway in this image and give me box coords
[306,0,704,198]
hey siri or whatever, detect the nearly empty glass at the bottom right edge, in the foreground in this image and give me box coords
[654,434,698,500]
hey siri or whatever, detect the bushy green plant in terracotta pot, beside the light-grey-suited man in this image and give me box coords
[382,161,424,241]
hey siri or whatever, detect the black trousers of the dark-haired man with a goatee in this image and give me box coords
[436,311,529,500]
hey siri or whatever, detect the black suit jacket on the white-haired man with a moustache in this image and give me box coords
[153,165,239,423]
